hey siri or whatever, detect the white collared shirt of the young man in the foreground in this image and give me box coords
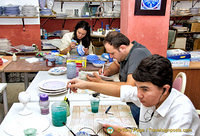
[120,85,200,136]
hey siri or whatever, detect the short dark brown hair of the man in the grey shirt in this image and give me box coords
[103,31,130,49]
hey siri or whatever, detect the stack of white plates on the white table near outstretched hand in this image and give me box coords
[39,79,67,95]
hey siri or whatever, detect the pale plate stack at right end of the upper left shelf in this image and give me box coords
[22,5,37,17]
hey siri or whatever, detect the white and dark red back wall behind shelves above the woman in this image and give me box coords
[41,2,120,32]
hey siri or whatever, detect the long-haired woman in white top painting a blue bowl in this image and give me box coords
[60,21,91,55]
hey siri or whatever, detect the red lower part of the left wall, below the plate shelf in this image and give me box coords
[0,25,41,49]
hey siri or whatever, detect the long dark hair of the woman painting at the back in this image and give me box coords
[73,21,91,48]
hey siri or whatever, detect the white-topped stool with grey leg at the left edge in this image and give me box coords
[0,83,8,115]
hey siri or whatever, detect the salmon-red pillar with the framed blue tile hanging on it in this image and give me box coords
[120,0,171,56]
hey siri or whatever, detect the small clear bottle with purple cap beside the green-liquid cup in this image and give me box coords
[39,94,49,115]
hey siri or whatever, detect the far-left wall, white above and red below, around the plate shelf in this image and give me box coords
[0,0,41,48]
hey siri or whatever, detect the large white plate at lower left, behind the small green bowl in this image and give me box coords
[4,115,50,136]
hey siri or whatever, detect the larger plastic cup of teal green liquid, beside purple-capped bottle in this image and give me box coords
[51,102,67,127]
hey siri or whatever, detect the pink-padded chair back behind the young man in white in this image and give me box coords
[172,72,187,93]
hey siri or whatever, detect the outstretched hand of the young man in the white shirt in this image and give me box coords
[67,78,87,93]
